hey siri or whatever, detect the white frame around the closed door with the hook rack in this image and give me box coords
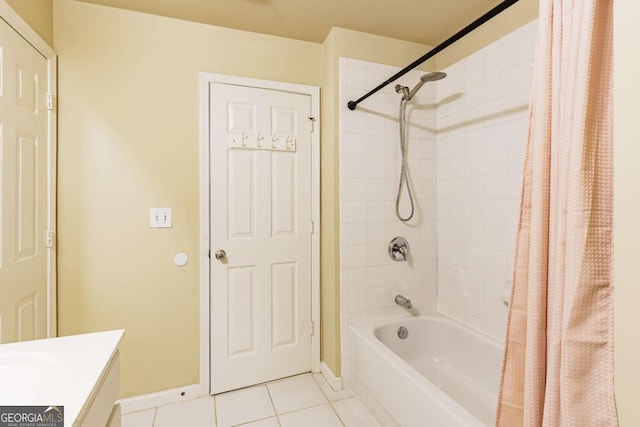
[200,72,320,396]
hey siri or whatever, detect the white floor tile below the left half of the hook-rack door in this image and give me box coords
[215,385,275,427]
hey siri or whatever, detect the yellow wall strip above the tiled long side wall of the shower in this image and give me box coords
[437,0,539,70]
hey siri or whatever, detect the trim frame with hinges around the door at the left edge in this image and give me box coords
[0,0,58,338]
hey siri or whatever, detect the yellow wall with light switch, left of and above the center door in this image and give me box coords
[54,0,322,397]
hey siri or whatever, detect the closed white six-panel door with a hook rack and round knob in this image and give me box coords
[209,83,313,393]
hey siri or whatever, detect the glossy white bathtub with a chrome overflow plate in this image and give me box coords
[348,314,502,427]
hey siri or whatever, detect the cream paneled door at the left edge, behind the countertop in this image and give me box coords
[0,19,50,343]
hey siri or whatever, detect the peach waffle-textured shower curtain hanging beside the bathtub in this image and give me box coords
[496,0,617,427]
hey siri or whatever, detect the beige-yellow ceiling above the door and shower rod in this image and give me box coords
[79,0,500,45]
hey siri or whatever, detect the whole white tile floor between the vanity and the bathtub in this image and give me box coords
[122,374,378,427]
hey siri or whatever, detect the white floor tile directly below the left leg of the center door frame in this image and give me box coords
[154,397,216,427]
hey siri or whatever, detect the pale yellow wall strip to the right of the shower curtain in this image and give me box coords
[613,1,640,426]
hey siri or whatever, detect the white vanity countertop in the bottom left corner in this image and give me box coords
[0,330,124,426]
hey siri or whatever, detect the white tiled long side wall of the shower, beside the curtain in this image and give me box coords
[437,21,537,340]
